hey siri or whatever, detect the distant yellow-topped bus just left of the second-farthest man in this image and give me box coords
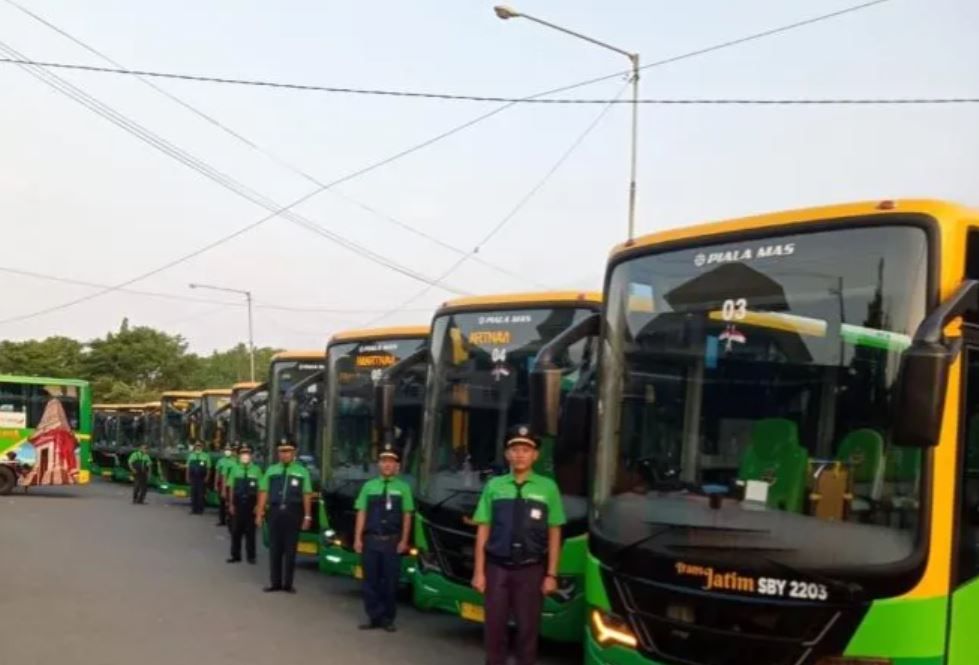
[156,390,204,497]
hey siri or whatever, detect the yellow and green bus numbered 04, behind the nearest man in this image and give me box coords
[413,292,601,641]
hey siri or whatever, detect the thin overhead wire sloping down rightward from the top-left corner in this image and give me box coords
[4,0,534,282]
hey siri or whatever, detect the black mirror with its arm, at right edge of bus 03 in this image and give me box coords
[892,280,979,448]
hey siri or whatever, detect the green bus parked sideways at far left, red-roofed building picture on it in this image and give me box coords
[0,374,92,495]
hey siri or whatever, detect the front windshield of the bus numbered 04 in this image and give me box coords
[419,307,592,505]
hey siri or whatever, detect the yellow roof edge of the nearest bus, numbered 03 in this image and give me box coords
[610,199,979,258]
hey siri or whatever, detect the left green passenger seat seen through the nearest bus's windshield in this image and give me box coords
[738,418,809,513]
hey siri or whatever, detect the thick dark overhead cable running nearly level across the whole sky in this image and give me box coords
[0,58,979,104]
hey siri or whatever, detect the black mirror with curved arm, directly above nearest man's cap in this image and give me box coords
[530,313,602,437]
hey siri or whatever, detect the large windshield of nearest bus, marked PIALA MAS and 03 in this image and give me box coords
[592,225,928,574]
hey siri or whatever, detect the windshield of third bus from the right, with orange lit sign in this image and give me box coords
[324,338,426,489]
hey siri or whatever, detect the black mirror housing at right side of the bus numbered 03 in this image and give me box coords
[892,342,952,448]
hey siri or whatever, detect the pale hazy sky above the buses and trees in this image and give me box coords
[0,0,979,353]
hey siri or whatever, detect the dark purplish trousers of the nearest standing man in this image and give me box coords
[483,562,544,665]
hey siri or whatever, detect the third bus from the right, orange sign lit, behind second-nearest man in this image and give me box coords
[319,326,429,585]
